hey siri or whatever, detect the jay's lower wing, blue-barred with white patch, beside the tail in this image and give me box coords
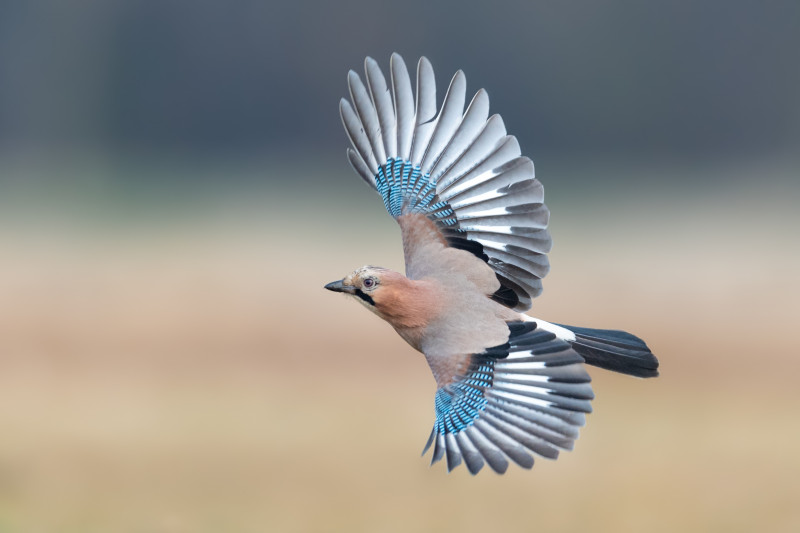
[422,321,594,474]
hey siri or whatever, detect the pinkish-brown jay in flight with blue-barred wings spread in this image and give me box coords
[325,53,659,475]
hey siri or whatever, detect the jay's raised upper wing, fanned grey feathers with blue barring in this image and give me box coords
[340,54,551,311]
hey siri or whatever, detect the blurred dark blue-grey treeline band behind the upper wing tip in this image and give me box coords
[0,0,800,164]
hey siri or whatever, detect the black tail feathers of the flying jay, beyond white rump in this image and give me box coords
[558,324,658,378]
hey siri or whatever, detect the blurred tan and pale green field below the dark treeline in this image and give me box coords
[0,160,800,532]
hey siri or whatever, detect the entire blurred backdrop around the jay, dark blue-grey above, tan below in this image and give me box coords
[0,0,800,532]
